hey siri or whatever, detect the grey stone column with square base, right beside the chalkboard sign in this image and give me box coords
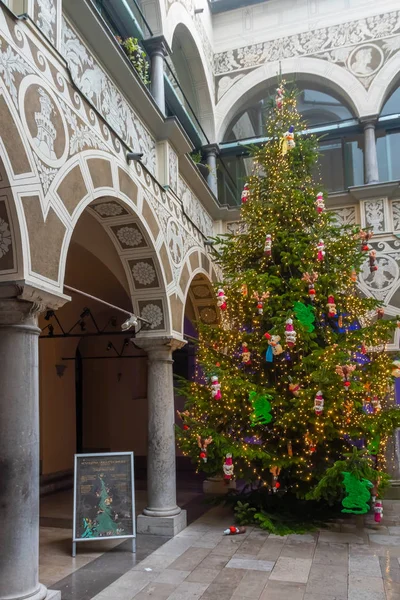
[134,336,186,536]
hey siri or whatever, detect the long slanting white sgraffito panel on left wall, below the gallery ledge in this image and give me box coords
[62,19,156,175]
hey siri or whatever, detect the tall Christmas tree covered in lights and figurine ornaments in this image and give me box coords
[177,84,400,506]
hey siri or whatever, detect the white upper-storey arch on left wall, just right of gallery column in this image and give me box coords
[166,14,215,142]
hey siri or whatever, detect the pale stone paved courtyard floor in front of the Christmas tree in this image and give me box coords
[88,501,400,600]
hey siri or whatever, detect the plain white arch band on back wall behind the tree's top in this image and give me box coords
[215,57,371,141]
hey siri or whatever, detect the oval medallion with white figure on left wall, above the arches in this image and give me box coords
[19,75,68,167]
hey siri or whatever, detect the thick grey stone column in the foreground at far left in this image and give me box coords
[0,298,47,600]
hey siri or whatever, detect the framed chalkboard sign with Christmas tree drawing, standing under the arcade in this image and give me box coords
[72,452,136,556]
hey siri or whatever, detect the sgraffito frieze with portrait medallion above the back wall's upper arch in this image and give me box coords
[214,11,400,98]
